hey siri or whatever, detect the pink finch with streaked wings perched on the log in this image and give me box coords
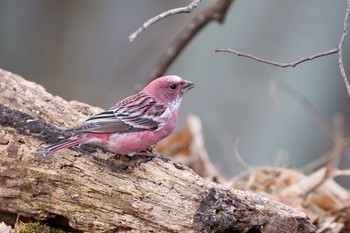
[39,75,194,156]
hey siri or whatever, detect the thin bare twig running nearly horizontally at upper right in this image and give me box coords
[215,48,339,68]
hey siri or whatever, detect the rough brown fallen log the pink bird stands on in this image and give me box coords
[0,69,315,232]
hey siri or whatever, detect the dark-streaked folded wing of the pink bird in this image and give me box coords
[67,93,167,133]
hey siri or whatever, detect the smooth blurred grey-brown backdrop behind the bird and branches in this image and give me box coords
[0,0,350,176]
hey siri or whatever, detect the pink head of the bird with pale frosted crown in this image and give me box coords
[143,75,194,107]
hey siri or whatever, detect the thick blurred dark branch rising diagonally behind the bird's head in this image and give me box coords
[149,0,234,81]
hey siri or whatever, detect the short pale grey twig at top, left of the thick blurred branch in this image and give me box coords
[129,0,202,42]
